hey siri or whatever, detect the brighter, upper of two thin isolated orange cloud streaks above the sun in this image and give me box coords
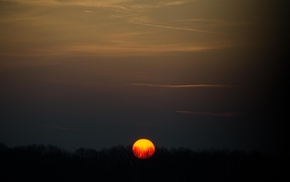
[130,83,230,88]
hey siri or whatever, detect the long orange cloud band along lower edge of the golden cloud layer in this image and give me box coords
[0,43,226,57]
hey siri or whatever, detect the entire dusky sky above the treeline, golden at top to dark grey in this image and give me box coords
[0,0,289,152]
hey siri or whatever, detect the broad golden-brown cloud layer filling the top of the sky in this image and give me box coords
[0,0,238,57]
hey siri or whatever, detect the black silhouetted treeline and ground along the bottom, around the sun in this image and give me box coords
[0,144,289,182]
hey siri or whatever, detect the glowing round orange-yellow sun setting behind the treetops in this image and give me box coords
[132,139,155,159]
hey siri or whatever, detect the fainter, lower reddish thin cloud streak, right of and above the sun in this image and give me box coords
[176,110,242,117]
